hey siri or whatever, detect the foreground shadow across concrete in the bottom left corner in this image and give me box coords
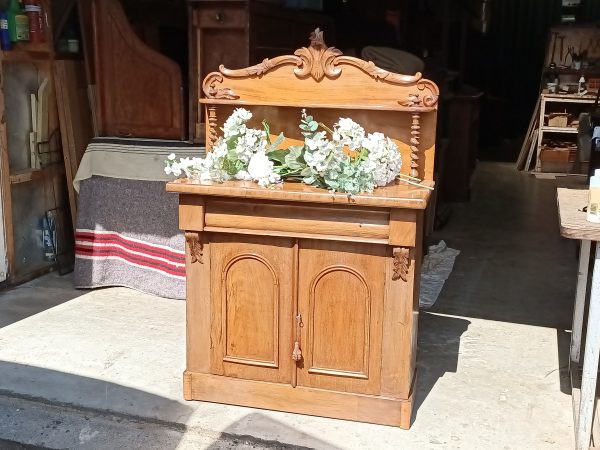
[0,361,193,450]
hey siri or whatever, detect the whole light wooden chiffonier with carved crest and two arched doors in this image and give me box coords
[167,31,438,428]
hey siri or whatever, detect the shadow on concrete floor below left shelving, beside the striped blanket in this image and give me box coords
[0,272,89,328]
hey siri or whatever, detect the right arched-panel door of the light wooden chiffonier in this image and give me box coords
[298,241,387,394]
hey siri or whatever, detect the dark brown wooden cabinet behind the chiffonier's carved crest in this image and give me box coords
[187,0,334,141]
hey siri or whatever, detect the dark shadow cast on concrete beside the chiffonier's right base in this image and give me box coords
[411,311,471,423]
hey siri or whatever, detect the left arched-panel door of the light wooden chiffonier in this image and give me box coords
[210,233,294,383]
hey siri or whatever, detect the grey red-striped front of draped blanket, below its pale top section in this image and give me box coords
[75,176,185,299]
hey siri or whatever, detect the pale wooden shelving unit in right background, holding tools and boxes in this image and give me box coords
[534,92,595,175]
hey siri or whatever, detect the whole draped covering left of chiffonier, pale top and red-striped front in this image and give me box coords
[75,139,203,299]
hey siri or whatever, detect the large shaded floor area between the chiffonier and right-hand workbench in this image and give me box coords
[431,163,577,330]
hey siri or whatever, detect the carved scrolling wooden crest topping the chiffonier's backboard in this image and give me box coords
[202,28,439,109]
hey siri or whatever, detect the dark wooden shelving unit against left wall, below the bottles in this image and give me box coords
[0,0,70,283]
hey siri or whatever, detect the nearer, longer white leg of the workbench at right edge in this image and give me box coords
[575,241,600,450]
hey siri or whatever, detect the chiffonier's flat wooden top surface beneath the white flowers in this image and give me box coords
[167,179,433,209]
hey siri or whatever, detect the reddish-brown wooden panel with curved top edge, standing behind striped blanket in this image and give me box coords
[87,0,187,140]
